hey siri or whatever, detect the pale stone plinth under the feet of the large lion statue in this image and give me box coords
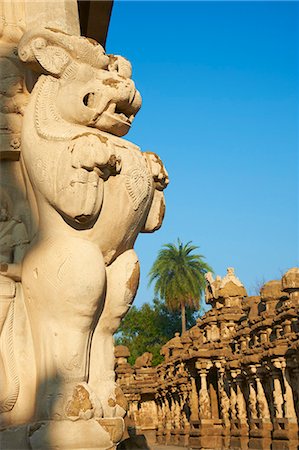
[0,417,124,450]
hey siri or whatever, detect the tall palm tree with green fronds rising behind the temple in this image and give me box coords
[149,239,213,333]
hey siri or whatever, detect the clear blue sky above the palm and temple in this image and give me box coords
[106,1,299,306]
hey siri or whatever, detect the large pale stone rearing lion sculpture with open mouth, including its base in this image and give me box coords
[0,23,168,450]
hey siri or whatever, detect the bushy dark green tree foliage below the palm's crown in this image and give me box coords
[115,299,196,365]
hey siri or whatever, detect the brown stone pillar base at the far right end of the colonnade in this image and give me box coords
[272,419,298,450]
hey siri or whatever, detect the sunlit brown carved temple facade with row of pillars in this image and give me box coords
[116,268,299,450]
